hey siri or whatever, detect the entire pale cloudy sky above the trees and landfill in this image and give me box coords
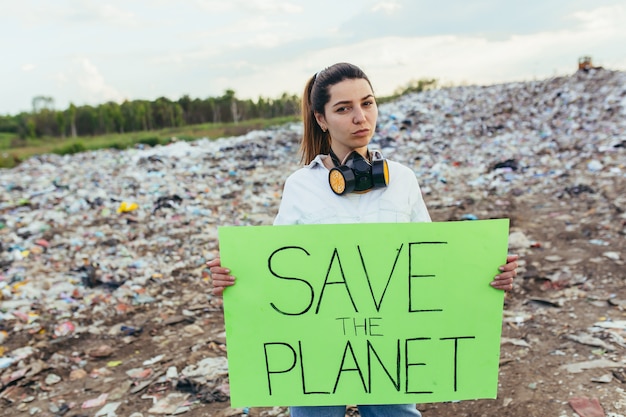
[0,0,626,115]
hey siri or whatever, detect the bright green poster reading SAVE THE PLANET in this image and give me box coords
[219,219,509,407]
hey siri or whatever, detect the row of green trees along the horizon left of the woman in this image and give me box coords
[0,89,300,139]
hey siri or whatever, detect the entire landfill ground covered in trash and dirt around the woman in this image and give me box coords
[0,69,626,417]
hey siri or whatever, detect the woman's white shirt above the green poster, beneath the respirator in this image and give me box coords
[274,155,431,225]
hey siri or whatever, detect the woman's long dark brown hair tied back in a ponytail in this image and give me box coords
[300,62,372,164]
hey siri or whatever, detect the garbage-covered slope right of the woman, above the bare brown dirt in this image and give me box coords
[378,71,626,207]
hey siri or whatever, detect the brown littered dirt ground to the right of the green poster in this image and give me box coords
[419,188,626,417]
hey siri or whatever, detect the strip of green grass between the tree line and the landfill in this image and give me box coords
[0,116,300,168]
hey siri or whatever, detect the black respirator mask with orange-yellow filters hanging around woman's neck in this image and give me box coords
[328,150,389,195]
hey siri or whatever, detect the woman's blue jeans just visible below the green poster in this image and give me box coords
[289,404,422,417]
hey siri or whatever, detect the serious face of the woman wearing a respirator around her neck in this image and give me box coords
[315,78,378,160]
